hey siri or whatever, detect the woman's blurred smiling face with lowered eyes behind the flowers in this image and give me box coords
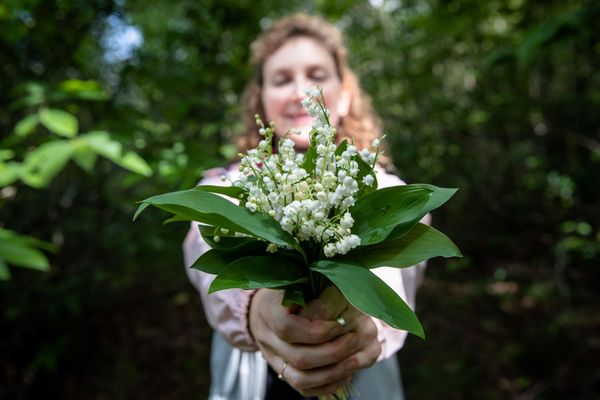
[262,36,350,150]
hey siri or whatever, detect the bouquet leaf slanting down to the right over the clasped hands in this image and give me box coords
[311,260,425,339]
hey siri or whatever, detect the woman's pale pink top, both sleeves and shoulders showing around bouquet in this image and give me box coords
[183,168,430,360]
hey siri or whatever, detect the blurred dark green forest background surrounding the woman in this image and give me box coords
[0,0,600,400]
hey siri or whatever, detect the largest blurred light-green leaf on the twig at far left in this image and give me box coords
[19,140,73,188]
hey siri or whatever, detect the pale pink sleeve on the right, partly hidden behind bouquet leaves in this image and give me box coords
[373,170,431,361]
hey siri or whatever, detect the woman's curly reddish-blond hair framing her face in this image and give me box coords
[239,14,380,151]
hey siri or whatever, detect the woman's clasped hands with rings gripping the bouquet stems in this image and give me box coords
[249,286,381,397]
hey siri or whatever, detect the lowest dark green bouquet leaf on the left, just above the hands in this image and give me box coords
[208,255,308,293]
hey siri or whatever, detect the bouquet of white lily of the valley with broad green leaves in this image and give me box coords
[134,88,460,337]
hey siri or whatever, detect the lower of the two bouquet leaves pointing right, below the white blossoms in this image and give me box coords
[340,223,462,268]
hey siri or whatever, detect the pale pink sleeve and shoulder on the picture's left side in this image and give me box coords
[183,170,258,351]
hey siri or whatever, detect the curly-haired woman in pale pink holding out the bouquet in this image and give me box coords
[184,15,421,399]
